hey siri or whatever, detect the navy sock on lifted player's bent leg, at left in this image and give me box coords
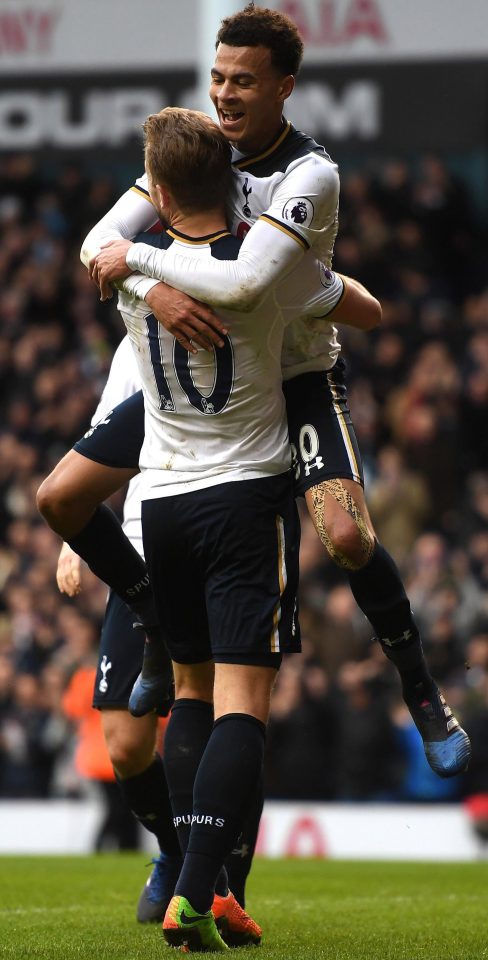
[68,503,156,623]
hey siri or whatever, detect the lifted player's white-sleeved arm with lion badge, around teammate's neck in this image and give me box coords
[124,157,339,311]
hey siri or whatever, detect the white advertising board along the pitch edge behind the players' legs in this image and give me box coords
[0,799,482,861]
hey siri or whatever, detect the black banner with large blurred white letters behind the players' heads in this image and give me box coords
[0,61,488,161]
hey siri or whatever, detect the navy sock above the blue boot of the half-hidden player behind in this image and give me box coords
[117,753,181,857]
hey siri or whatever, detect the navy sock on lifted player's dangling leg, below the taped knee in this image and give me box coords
[349,543,432,688]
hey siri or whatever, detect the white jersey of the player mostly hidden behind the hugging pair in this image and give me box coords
[91,337,144,557]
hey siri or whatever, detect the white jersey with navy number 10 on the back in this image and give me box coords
[119,223,337,499]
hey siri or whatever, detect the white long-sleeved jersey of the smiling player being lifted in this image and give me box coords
[127,123,340,379]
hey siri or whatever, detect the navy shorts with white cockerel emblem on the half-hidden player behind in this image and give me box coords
[93,591,146,710]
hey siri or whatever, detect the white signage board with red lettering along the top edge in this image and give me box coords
[0,0,488,74]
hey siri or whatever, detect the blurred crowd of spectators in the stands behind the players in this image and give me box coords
[0,156,488,816]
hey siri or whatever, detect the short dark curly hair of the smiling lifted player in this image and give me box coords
[215,3,303,77]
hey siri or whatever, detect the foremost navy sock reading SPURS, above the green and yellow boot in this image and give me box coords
[175,713,266,913]
